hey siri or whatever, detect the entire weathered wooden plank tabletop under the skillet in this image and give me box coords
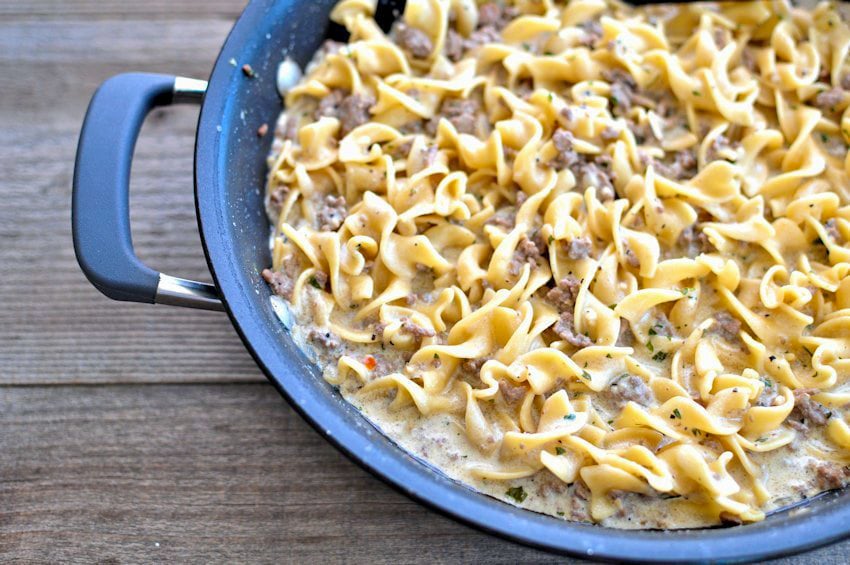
[0,0,850,563]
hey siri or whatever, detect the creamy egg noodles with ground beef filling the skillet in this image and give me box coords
[263,0,850,528]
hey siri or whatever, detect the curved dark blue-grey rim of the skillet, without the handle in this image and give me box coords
[194,0,850,563]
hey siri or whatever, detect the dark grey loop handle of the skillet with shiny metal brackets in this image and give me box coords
[71,73,224,310]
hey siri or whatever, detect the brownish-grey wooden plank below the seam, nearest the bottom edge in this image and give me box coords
[0,385,554,563]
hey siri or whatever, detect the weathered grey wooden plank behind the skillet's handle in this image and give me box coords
[0,12,263,384]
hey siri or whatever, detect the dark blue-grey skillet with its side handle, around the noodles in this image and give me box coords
[73,0,850,562]
